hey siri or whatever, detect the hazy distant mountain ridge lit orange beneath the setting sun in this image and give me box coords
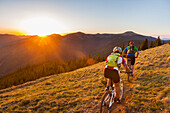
[0,31,166,76]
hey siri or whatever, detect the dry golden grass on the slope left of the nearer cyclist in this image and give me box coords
[0,62,104,112]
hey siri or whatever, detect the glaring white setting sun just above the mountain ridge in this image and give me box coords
[21,17,64,36]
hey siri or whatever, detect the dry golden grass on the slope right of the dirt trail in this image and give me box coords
[124,44,170,113]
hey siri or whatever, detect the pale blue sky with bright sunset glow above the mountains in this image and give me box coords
[0,0,170,39]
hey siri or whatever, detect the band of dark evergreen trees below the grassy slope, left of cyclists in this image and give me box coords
[0,53,106,89]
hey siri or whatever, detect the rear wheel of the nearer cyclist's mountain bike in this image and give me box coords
[100,91,111,113]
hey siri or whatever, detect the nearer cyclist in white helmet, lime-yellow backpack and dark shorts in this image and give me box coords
[104,47,130,103]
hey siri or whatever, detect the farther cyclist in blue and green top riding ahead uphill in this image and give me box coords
[122,42,139,73]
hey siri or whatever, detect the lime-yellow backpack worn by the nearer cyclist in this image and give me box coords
[107,53,120,67]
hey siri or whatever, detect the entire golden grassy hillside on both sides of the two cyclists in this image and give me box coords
[0,44,170,113]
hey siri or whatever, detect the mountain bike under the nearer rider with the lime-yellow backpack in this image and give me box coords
[100,71,131,113]
